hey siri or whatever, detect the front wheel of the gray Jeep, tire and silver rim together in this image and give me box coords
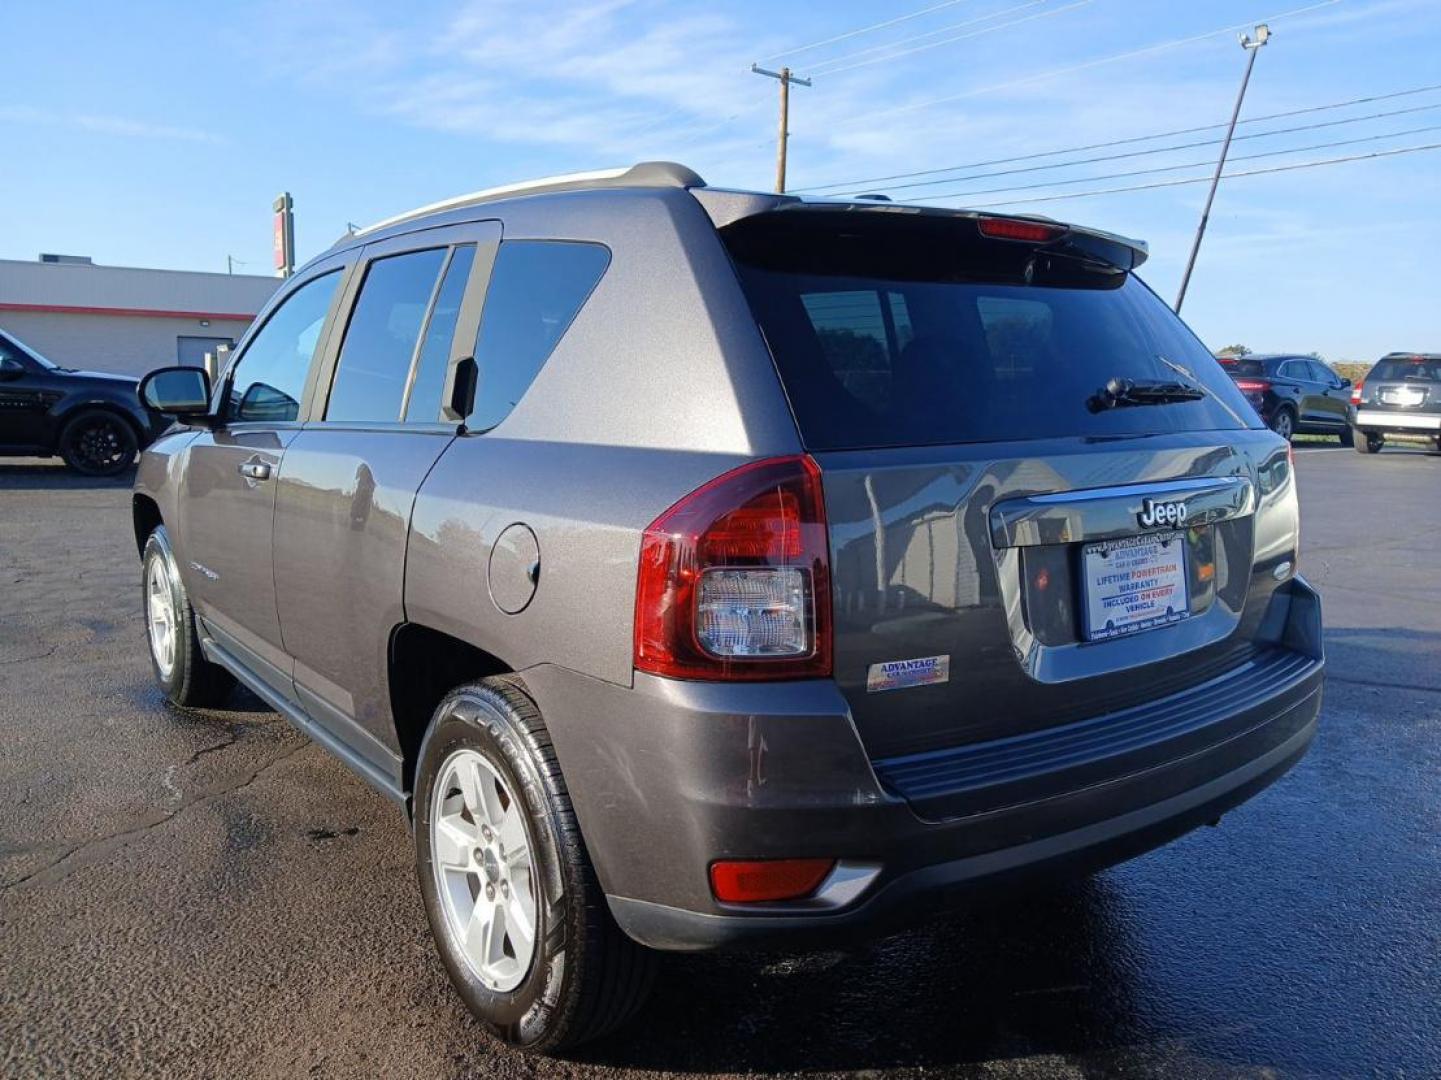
[140,525,235,708]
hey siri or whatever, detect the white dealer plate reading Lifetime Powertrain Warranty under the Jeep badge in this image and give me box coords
[1081,532,1190,642]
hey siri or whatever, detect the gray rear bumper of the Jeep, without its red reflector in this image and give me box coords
[526,580,1323,949]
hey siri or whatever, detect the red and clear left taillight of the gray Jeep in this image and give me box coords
[635,456,831,681]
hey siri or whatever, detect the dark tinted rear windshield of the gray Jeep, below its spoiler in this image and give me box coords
[723,212,1257,450]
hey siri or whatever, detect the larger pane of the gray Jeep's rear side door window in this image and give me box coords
[326,248,447,422]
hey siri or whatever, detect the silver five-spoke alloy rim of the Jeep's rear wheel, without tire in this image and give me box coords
[429,748,539,993]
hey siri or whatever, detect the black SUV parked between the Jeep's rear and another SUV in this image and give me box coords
[1221,355,1352,446]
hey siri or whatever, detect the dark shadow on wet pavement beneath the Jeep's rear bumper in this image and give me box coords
[576,875,1138,1073]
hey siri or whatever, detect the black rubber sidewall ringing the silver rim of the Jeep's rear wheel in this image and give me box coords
[414,686,576,1048]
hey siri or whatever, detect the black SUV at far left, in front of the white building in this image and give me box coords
[0,325,167,476]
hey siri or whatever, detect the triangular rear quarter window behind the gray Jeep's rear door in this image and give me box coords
[468,241,611,431]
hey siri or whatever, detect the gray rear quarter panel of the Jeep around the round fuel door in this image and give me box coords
[405,190,801,683]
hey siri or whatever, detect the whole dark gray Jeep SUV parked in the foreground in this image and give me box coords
[134,163,1323,1050]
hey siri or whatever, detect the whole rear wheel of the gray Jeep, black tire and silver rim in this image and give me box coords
[415,676,656,1054]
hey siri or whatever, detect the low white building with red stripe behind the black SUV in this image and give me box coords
[0,255,280,375]
